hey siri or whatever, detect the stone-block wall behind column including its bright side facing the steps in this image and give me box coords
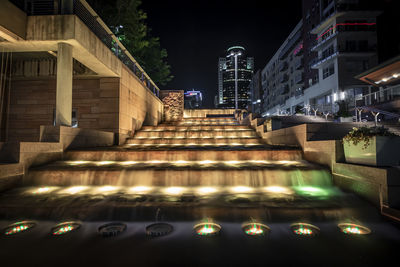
[8,70,163,142]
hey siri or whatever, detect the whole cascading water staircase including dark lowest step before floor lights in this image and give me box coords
[0,115,337,220]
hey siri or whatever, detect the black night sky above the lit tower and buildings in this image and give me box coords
[142,0,301,107]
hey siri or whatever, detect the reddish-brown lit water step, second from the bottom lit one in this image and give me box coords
[64,147,302,161]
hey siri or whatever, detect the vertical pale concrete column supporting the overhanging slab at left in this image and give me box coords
[56,43,72,126]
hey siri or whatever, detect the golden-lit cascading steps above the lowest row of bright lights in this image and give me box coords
[25,118,329,187]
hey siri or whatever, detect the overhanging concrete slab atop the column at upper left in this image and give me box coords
[0,15,122,77]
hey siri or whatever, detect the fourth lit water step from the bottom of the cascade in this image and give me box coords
[134,129,257,139]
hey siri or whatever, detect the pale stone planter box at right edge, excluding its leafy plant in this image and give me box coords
[343,136,400,166]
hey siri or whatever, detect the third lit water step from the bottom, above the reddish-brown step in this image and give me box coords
[126,137,263,146]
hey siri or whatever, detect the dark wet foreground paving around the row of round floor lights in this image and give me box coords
[0,222,399,266]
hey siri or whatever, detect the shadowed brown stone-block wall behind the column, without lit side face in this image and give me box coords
[8,78,119,142]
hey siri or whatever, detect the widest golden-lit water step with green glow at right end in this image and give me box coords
[24,161,331,188]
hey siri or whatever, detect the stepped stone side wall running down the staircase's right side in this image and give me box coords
[248,114,400,213]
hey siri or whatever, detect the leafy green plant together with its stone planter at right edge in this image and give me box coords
[343,126,400,166]
